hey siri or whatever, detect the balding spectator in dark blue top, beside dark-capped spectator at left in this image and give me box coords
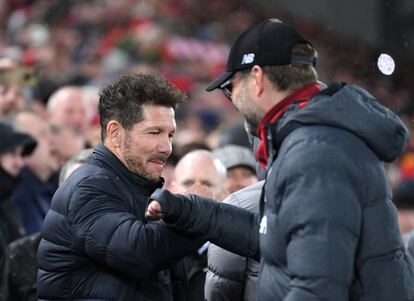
[13,111,59,234]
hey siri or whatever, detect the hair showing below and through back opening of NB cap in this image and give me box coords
[263,43,318,91]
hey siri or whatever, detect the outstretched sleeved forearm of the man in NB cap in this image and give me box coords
[151,189,260,259]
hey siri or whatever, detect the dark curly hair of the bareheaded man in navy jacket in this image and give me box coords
[98,73,187,142]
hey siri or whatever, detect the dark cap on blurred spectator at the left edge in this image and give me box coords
[0,121,37,156]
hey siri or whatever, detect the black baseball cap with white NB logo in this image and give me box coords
[206,19,316,91]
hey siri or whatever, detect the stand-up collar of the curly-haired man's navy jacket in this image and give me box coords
[93,144,164,193]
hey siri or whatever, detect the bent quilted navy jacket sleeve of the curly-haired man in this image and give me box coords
[69,178,202,279]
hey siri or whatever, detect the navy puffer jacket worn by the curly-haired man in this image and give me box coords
[38,145,201,301]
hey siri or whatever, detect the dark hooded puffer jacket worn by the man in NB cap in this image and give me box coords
[153,85,414,301]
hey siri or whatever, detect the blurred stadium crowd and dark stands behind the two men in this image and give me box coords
[0,0,414,187]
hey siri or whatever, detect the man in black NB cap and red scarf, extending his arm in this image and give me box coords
[148,19,414,301]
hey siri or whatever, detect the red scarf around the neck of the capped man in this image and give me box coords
[256,83,321,169]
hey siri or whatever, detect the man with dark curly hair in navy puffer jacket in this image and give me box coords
[38,74,202,301]
